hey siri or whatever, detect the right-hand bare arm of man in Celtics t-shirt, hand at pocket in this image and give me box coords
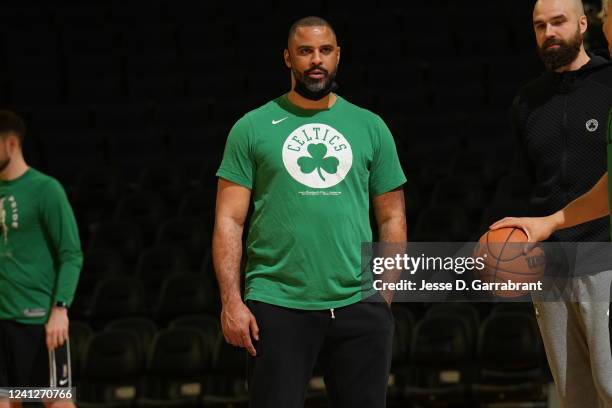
[372,187,408,304]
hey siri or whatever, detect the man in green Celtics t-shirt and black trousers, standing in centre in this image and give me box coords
[213,17,406,408]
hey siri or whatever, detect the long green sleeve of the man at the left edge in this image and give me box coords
[41,180,83,305]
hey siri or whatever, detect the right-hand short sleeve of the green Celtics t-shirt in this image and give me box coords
[370,116,406,196]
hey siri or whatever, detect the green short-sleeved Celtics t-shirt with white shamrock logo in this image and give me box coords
[217,95,406,310]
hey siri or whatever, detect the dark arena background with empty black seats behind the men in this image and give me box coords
[0,0,605,406]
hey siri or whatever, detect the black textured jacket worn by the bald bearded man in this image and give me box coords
[512,56,612,274]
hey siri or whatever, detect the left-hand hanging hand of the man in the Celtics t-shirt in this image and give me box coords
[221,300,259,357]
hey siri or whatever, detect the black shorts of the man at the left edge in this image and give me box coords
[0,320,72,388]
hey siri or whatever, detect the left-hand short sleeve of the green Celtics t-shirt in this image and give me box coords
[217,115,255,189]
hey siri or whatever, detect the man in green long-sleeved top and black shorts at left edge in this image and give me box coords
[0,111,83,408]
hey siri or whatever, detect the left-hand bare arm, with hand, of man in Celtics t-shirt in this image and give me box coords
[213,178,259,356]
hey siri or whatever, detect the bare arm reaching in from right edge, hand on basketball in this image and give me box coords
[490,173,610,242]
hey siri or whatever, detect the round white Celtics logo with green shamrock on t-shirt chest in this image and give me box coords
[283,123,353,188]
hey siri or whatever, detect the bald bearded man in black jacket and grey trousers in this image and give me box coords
[513,0,612,408]
